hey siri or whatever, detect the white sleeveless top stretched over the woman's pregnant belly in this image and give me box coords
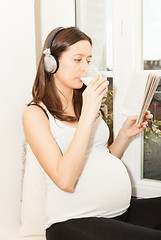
[38,104,131,229]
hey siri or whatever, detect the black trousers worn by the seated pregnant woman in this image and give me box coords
[46,197,161,240]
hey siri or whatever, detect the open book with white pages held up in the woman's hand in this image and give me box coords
[121,71,160,124]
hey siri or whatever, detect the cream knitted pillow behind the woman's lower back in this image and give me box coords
[20,144,46,237]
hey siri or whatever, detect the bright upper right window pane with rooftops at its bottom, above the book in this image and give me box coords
[143,0,161,70]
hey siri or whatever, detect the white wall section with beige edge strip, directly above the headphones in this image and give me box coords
[35,0,75,62]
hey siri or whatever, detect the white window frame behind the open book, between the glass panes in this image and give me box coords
[113,0,161,197]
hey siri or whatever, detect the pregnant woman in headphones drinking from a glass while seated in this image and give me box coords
[23,27,161,240]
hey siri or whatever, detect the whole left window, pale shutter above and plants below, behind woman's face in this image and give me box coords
[76,0,113,145]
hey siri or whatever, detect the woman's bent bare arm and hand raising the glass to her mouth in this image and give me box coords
[23,79,107,192]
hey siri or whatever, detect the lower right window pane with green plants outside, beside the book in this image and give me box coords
[143,82,161,180]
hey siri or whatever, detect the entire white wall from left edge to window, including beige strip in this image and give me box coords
[0,0,75,236]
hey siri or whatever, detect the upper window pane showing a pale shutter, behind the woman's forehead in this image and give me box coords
[76,0,106,71]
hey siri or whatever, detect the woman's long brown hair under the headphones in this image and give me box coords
[28,27,92,122]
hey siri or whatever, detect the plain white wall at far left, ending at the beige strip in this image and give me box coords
[0,0,35,232]
